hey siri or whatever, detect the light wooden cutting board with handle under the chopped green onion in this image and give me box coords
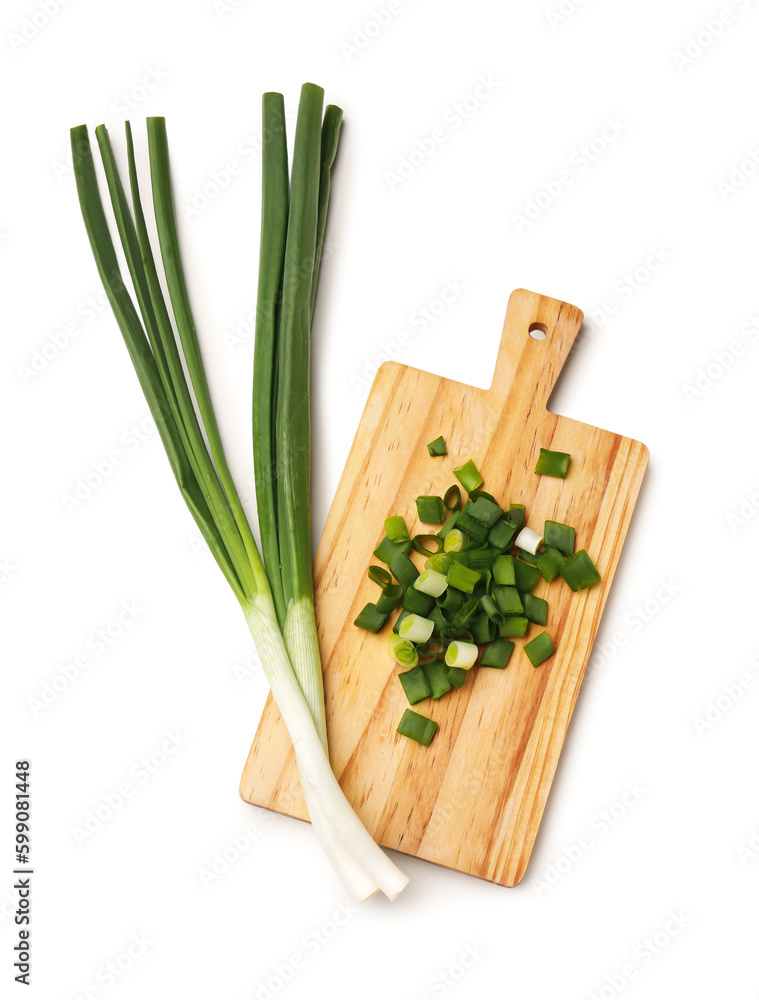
[240,289,648,886]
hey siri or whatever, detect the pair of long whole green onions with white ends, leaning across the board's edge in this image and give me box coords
[71,84,408,900]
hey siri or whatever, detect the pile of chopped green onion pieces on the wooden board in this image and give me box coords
[354,437,601,746]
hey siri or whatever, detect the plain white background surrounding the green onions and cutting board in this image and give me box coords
[0,0,759,1000]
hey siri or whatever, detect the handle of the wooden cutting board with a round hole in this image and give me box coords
[490,288,582,419]
